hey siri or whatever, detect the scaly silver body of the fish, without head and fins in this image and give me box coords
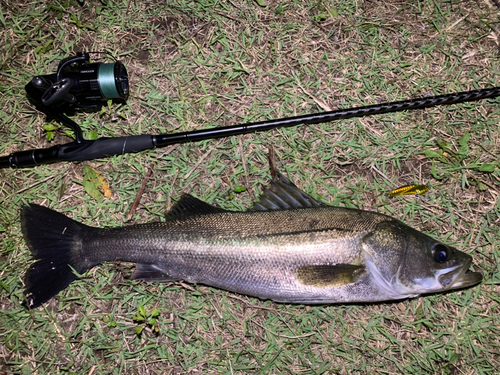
[83,207,382,300]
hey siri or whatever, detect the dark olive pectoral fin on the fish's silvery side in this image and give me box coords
[295,264,365,288]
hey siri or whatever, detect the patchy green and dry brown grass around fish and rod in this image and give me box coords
[0,0,500,375]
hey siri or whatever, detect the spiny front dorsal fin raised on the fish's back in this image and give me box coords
[250,172,326,211]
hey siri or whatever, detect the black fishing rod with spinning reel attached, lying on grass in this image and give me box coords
[0,52,500,168]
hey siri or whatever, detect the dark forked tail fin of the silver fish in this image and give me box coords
[21,204,95,309]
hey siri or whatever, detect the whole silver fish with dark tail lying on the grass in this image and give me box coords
[21,172,482,309]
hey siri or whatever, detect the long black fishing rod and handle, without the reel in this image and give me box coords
[0,87,500,168]
